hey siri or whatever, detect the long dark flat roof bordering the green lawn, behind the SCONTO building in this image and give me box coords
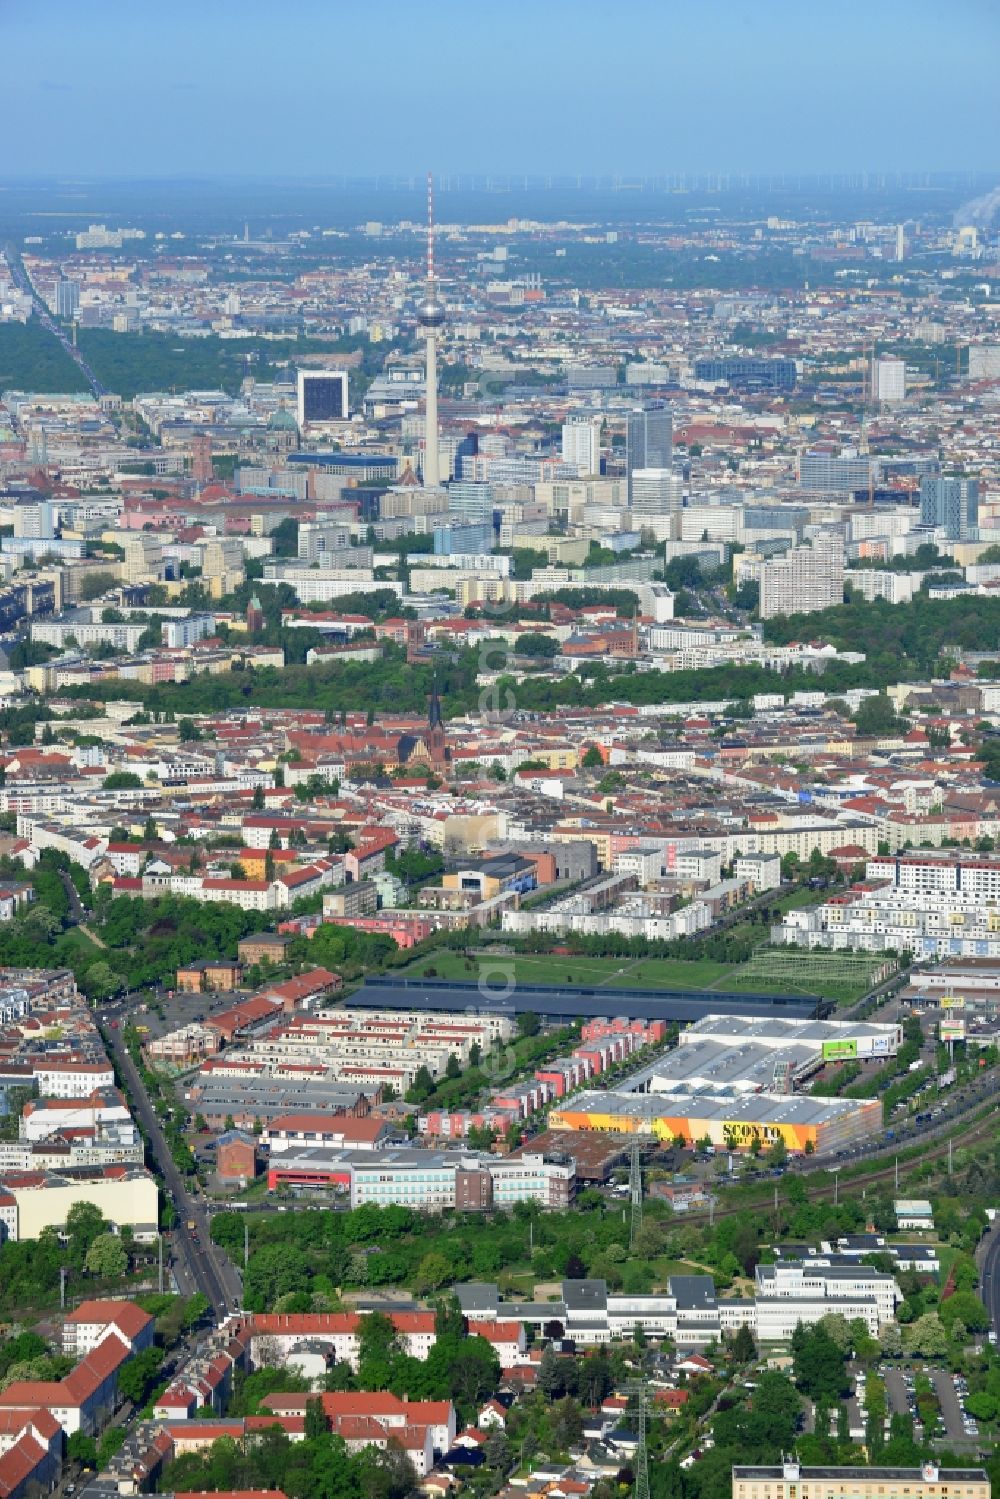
[346,977,829,1022]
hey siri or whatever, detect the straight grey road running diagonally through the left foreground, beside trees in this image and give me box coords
[106,1030,243,1318]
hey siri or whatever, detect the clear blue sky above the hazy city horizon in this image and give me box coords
[7,0,1000,177]
